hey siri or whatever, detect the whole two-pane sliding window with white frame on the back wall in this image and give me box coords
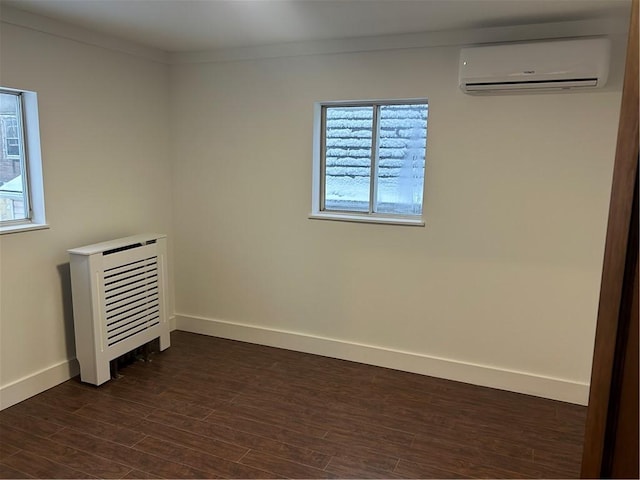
[311,99,428,225]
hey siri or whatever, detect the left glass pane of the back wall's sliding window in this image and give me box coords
[324,106,373,212]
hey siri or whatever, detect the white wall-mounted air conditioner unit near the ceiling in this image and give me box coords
[458,37,611,95]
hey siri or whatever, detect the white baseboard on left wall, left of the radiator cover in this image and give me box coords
[0,358,80,410]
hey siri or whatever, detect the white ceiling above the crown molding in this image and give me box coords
[0,0,631,52]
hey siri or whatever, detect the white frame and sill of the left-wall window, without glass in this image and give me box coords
[0,86,49,235]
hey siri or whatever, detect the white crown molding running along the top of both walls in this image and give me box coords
[1,5,629,65]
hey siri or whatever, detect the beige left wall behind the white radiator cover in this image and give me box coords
[0,23,171,404]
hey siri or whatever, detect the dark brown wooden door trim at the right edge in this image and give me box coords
[581,0,638,478]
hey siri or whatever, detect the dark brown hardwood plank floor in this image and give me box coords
[0,331,586,478]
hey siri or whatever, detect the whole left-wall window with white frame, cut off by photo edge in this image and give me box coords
[0,88,46,233]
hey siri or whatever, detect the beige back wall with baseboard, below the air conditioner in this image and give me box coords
[171,47,620,402]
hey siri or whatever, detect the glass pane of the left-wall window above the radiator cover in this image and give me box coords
[0,93,28,221]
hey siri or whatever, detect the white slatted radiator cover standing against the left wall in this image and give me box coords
[68,234,170,385]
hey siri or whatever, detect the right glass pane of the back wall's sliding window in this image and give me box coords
[375,104,428,215]
